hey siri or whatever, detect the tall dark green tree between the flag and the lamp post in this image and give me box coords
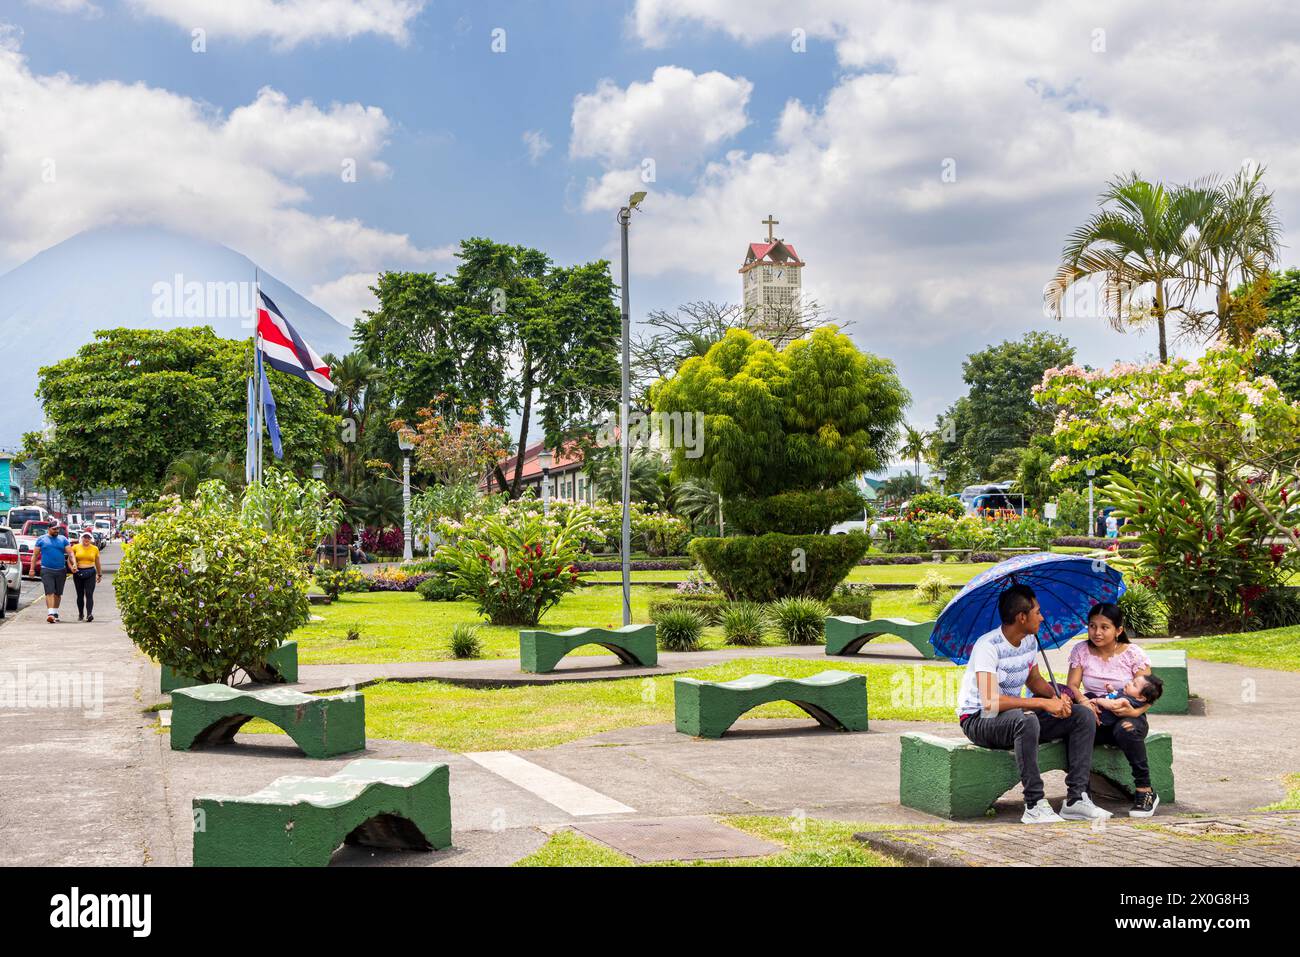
[354,238,620,495]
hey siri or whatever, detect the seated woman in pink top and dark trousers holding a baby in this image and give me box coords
[1066,602,1160,818]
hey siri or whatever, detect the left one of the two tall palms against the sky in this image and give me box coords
[1044,173,1214,363]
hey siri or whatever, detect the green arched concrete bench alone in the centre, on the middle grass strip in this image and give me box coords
[673,671,867,737]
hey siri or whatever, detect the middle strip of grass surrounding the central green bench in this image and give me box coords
[242,658,961,752]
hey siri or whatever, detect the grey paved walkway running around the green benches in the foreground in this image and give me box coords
[0,561,1300,866]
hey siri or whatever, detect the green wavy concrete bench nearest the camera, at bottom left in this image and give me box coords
[194,758,451,867]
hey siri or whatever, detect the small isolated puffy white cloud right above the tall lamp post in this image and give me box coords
[569,66,754,169]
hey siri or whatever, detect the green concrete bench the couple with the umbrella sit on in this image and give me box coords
[898,731,1174,818]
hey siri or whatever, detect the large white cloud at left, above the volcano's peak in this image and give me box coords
[0,34,438,285]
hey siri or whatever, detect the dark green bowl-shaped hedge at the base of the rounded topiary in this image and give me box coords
[690,532,871,602]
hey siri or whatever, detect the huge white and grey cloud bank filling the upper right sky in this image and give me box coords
[613,0,1300,361]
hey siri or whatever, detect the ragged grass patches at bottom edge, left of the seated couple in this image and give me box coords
[515,815,898,867]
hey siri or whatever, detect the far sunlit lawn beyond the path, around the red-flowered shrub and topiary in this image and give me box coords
[291,585,935,664]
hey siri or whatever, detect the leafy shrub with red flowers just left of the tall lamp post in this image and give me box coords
[438,508,590,625]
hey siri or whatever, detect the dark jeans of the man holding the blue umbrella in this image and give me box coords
[962,705,1097,806]
